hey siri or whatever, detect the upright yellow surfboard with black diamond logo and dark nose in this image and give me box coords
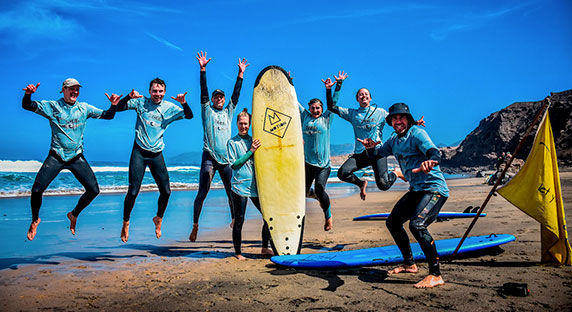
[252,66,306,255]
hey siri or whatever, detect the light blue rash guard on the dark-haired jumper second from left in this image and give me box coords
[127,97,185,153]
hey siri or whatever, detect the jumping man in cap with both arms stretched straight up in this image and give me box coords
[189,51,249,242]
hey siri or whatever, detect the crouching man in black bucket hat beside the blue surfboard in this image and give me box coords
[359,103,449,288]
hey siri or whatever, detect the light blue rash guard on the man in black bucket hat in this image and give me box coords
[374,126,449,197]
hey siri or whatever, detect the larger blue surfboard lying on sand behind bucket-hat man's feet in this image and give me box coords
[270,234,515,269]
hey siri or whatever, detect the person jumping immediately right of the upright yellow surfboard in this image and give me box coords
[298,72,347,231]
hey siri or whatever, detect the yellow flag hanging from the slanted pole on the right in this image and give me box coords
[497,110,572,265]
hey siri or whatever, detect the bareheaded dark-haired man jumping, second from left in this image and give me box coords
[117,78,193,242]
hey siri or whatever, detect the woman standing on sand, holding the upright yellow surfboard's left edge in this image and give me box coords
[227,108,274,260]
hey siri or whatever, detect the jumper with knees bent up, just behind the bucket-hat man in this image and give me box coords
[328,77,425,200]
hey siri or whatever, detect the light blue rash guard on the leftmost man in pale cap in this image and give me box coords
[32,98,103,161]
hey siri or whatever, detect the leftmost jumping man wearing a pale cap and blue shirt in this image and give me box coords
[22,78,121,240]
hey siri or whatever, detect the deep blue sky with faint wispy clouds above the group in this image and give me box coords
[0,0,572,161]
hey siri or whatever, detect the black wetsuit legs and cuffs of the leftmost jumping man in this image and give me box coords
[22,94,116,222]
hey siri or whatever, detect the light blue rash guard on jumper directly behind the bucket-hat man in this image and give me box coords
[337,105,388,154]
